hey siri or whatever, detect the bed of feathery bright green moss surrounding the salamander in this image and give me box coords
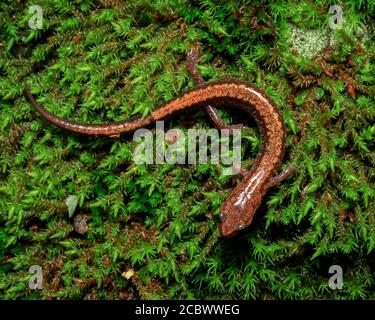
[0,0,375,299]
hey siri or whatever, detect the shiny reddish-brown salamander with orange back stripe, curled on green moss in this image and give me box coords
[25,43,294,237]
